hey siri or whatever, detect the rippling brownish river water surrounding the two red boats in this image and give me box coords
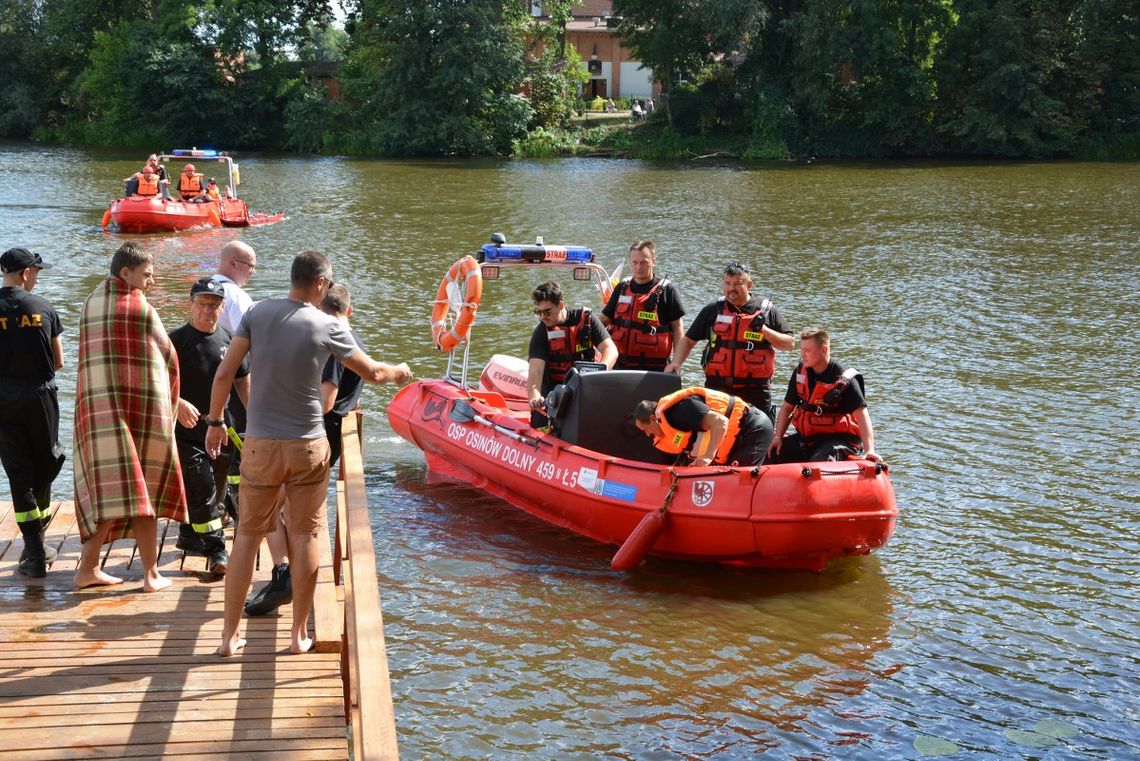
[0,144,1140,760]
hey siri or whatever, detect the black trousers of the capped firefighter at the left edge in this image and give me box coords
[0,378,64,537]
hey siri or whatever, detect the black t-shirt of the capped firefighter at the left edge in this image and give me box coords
[0,286,64,384]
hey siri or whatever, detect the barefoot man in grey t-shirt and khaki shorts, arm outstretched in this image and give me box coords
[206,251,412,656]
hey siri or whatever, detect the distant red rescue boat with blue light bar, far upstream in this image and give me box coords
[103,148,285,232]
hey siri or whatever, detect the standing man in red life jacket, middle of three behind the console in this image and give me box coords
[602,235,685,373]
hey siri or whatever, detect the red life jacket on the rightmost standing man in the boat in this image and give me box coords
[701,297,776,388]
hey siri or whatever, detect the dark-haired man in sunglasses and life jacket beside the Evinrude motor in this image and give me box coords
[527,280,618,428]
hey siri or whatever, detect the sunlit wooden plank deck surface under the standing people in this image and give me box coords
[0,502,349,761]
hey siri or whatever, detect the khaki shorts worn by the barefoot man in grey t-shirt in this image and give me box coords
[237,436,328,537]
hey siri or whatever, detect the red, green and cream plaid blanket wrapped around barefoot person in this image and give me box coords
[72,277,186,541]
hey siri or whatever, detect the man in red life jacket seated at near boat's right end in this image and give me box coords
[768,328,882,463]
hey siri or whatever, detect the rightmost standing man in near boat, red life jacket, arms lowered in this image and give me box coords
[665,262,796,420]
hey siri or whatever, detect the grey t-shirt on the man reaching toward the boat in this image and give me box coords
[237,298,357,439]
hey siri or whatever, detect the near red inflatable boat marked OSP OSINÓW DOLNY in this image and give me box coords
[388,236,898,571]
